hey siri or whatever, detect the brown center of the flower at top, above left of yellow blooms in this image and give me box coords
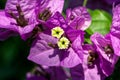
[39,9,52,21]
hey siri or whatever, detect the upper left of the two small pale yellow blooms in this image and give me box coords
[52,27,64,39]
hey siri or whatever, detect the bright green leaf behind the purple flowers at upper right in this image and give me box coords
[86,10,112,35]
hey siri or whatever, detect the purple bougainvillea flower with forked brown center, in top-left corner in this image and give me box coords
[0,0,39,39]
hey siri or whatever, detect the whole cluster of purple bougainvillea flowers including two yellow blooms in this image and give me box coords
[0,0,120,80]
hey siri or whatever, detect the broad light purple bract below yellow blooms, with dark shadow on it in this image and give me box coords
[28,35,81,67]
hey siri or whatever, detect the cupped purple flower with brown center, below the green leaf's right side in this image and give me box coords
[91,33,118,76]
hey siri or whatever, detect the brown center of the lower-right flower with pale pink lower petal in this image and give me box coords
[87,50,98,67]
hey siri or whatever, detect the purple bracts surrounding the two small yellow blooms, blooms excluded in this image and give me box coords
[28,12,82,67]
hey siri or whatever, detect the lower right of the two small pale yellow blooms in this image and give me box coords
[57,37,70,49]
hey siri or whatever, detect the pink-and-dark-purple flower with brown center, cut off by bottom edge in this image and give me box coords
[70,44,105,80]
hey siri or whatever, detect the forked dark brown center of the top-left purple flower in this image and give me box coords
[8,4,28,27]
